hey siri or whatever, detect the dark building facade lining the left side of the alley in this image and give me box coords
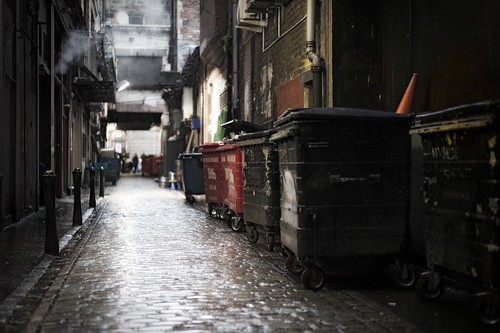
[0,0,116,229]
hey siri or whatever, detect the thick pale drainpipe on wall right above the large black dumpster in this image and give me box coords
[306,0,323,107]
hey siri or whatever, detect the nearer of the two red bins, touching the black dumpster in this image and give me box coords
[219,140,245,231]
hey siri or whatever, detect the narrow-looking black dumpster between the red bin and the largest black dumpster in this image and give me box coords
[235,130,280,251]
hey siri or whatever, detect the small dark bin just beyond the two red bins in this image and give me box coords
[179,153,205,203]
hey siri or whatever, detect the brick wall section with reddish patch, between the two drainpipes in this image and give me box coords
[239,1,309,127]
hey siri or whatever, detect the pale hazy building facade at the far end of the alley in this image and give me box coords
[105,0,199,175]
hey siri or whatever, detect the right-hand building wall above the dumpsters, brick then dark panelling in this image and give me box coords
[190,0,500,142]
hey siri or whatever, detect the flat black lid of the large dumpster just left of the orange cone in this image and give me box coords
[274,107,415,126]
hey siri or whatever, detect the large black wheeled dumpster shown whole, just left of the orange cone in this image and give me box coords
[271,108,413,290]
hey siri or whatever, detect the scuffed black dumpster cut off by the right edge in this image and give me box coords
[411,102,500,324]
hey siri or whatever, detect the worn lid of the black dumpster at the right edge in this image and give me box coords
[410,101,500,133]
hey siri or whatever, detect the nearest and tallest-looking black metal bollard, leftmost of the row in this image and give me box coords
[42,170,59,255]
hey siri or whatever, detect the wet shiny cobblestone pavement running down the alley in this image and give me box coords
[19,177,420,332]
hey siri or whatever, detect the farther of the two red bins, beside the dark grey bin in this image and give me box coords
[200,142,227,218]
